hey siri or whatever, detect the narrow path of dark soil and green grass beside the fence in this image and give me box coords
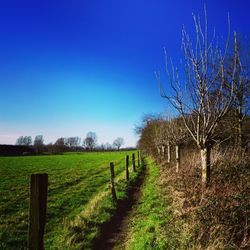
[93,159,171,250]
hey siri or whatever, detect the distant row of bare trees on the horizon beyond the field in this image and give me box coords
[16,132,124,151]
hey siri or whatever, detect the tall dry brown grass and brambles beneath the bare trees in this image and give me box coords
[160,147,250,249]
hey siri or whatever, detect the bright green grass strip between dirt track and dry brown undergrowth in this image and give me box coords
[126,157,171,250]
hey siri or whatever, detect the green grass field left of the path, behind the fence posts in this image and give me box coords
[0,151,138,249]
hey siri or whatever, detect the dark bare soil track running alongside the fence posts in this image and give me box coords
[93,169,146,250]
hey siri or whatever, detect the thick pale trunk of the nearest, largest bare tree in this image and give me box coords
[200,147,211,188]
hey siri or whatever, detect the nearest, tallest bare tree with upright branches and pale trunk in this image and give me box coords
[157,9,236,187]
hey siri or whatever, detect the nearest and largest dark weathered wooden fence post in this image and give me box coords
[28,174,48,250]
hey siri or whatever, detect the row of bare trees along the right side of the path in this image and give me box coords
[138,10,250,186]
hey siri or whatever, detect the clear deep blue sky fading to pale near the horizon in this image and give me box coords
[0,0,250,146]
